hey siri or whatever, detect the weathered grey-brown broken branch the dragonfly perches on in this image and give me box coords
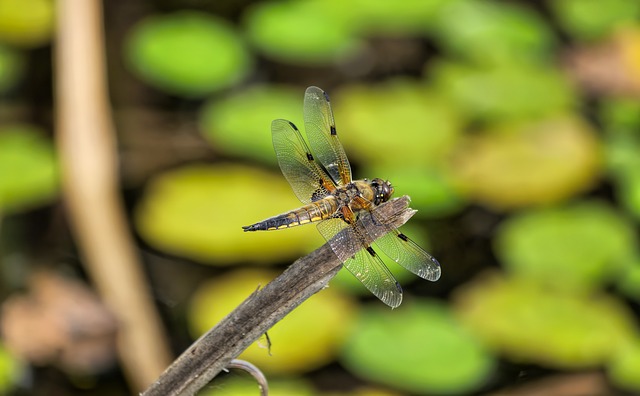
[142,196,415,396]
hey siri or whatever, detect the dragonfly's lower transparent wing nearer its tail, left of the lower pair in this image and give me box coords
[318,218,402,308]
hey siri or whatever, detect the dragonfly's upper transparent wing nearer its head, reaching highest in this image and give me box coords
[304,87,351,185]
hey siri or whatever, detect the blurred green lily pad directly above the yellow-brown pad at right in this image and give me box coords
[436,62,578,121]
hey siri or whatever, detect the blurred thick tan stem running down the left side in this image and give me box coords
[54,0,171,390]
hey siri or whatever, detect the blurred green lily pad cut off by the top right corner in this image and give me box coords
[548,0,640,40]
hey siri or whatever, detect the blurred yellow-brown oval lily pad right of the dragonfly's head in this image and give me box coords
[452,117,602,210]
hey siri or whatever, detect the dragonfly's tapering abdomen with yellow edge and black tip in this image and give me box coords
[242,196,338,231]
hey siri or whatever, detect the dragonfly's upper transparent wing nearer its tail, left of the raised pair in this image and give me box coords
[271,120,336,204]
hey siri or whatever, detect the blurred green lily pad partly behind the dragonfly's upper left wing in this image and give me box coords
[200,86,304,164]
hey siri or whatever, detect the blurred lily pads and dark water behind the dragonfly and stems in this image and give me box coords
[0,0,640,395]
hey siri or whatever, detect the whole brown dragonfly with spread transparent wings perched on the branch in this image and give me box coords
[242,86,441,308]
